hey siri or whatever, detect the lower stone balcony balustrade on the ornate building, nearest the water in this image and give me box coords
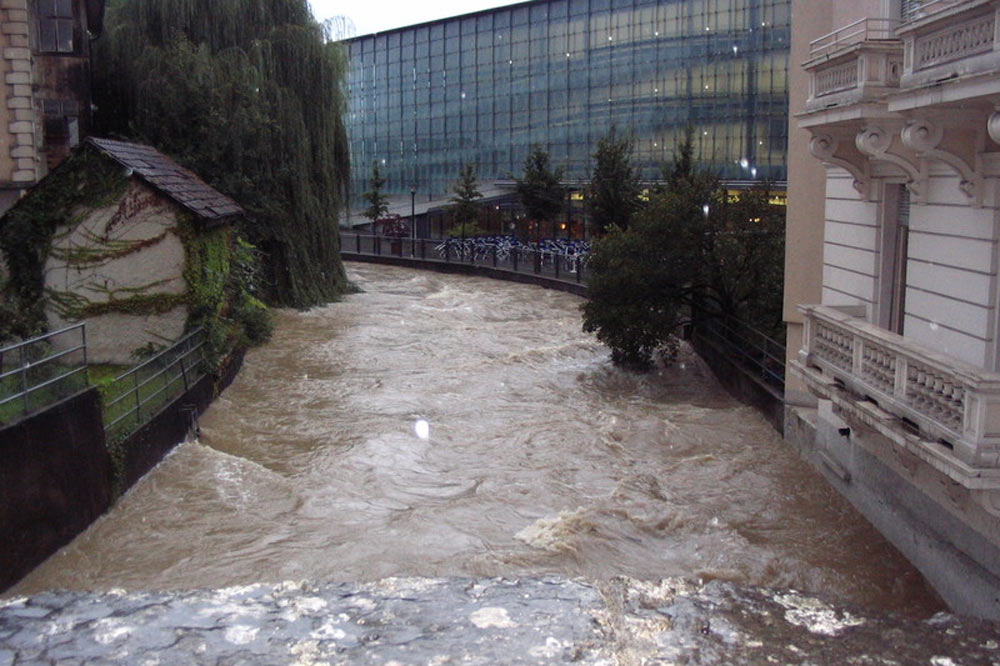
[799,305,1000,474]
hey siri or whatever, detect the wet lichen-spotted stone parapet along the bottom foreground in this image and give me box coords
[0,577,1000,666]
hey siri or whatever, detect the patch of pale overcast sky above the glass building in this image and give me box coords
[309,0,518,36]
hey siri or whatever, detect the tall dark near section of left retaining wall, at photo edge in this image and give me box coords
[0,388,112,590]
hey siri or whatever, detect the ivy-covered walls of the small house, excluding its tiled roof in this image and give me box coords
[0,148,270,364]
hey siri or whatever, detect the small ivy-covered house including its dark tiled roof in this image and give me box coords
[0,138,243,364]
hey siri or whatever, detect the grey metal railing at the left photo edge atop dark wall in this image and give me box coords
[0,324,87,424]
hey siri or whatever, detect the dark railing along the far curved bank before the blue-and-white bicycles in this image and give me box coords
[340,232,588,284]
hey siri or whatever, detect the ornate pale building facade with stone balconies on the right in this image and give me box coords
[785,0,1000,619]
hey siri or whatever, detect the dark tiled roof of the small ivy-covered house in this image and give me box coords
[87,137,243,223]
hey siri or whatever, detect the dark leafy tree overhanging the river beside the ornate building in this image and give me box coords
[582,132,784,370]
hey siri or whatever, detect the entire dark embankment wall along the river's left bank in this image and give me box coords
[0,351,243,588]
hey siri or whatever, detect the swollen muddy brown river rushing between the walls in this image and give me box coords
[9,264,942,616]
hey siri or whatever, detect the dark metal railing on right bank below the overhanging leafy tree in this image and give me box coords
[695,314,785,395]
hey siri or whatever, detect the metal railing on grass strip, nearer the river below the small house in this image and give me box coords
[104,328,205,438]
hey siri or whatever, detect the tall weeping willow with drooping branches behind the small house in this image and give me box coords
[94,0,349,307]
